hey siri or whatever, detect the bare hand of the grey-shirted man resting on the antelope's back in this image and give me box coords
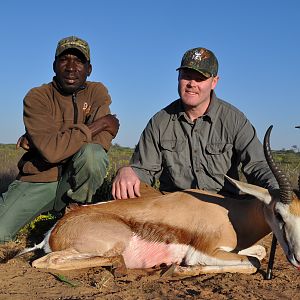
[112,167,141,199]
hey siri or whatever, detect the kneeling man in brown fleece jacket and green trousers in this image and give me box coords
[0,36,119,243]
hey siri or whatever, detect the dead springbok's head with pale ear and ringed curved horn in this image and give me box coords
[226,126,300,270]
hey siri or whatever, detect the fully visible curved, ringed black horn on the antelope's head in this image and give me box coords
[264,125,293,204]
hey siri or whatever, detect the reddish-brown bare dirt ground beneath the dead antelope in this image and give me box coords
[0,235,300,300]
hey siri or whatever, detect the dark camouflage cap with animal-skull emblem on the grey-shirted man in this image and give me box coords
[177,48,218,78]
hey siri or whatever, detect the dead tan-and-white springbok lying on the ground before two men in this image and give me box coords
[21,126,300,276]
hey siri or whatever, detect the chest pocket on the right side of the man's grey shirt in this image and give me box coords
[205,143,233,174]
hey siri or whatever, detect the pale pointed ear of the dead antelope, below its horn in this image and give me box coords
[225,175,272,204]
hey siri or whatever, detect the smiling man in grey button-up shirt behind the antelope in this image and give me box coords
[112,47,278,199]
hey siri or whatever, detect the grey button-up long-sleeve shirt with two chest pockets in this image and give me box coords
[130,92,278,193]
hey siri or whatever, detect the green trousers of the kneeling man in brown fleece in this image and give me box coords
[0,144,108,243]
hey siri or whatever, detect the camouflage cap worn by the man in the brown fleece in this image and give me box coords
[55,36,90,61]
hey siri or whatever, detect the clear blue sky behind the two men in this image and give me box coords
[0,0,300,149]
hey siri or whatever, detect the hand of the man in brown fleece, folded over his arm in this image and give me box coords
[88,114,120,137]
